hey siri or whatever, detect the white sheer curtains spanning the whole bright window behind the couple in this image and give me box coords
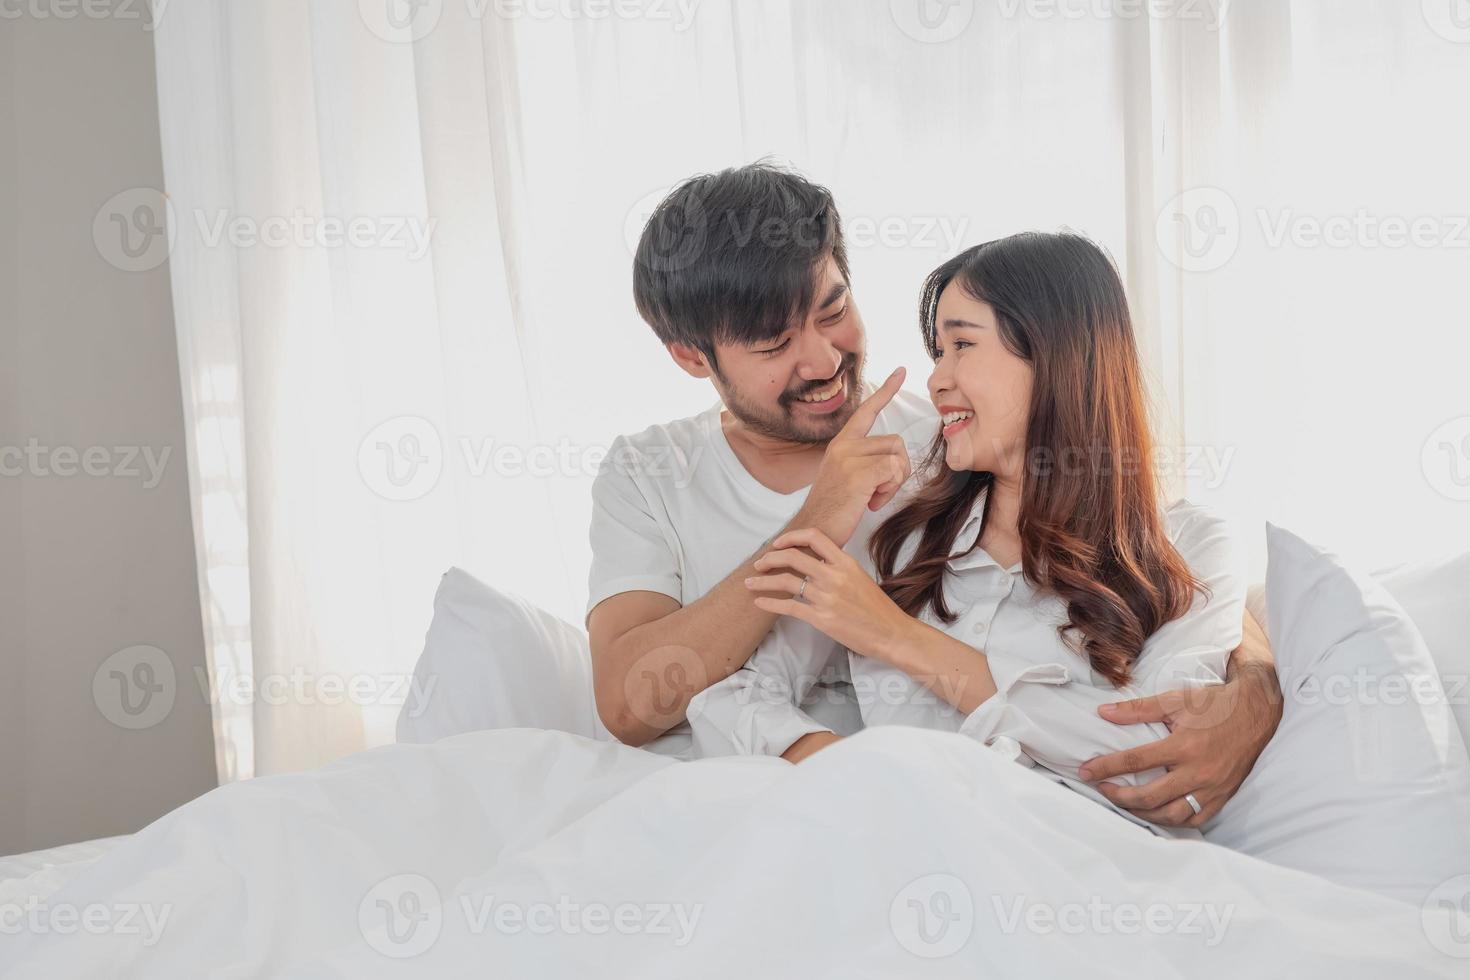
[149,0,1470,780]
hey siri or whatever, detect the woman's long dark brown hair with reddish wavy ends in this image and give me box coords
[870,232,1204,686]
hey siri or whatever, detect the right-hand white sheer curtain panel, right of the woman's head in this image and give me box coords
[1160,0,1470,573]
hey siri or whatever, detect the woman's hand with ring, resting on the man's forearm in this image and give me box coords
[745,527,917,663]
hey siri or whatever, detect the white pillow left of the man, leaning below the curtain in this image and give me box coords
[398,569,612,742]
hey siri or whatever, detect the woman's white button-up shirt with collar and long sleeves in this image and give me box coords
[688,494,1247,836]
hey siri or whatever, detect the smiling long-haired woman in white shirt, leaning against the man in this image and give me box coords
[689,234,1245,834]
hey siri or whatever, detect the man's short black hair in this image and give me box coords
[634,162,848,369]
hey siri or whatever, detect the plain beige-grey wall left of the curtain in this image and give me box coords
[0,4,215,854]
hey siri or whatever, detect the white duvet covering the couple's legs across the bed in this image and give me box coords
[0,727,1470,980]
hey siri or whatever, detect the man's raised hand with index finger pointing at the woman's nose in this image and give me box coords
[786,367,911,548]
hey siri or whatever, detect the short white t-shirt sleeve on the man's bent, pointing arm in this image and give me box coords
[587,436,684,614]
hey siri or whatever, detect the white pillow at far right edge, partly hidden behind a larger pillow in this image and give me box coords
[1374,551,1470,743]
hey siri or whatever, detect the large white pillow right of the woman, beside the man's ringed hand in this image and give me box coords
[1205,525,1470,904]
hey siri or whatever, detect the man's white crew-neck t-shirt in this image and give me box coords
[587,385,938,755]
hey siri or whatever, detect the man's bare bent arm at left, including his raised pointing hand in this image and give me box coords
[587,369,910,745]
